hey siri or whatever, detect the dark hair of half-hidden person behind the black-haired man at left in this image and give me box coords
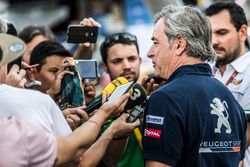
[18,25,55,43]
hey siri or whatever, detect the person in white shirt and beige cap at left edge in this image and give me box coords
[0,33,72,136]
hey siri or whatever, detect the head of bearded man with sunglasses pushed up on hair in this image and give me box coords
[100,33,141,81]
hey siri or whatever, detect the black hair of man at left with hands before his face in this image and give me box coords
[30,40,72,70]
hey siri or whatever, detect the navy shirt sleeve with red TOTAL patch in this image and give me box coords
[143,92,185,166]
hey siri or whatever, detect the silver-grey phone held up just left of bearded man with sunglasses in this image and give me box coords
[75,59,98,79]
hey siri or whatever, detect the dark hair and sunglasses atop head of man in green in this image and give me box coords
[100,32,139,64]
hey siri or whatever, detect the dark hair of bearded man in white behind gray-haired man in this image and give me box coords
[204,1,250,48]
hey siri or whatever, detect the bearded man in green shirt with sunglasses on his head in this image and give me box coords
[100,32,144,167]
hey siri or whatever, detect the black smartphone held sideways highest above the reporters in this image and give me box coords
[67,25,98,43]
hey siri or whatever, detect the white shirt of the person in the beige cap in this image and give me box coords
[0,84,72,136]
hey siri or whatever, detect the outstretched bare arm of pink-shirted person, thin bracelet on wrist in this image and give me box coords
[56,93,129,165]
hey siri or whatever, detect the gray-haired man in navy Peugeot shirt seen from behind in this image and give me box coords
[143,6,246,167]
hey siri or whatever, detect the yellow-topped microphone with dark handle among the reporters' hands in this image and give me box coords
[85,77,128,114]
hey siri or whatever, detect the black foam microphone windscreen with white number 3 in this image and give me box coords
[125,83,147,110]
